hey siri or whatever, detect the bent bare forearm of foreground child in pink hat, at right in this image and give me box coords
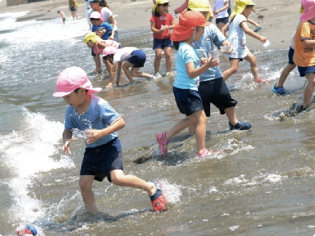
[85,117,126,144]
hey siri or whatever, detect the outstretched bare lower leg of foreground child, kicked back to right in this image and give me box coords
[110,169,156,196]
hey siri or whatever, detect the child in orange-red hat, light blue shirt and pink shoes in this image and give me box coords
[156,11,218,159]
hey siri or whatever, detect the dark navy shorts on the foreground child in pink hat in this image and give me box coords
[80,138,123,182]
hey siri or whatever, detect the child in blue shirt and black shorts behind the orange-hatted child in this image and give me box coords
[191,3,252,130]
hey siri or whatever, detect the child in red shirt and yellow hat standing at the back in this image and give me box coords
[150,0,174,78]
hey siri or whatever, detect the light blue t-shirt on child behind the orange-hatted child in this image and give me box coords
[194,24,226,82]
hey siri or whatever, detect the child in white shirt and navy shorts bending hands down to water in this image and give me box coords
[103,47,154,86]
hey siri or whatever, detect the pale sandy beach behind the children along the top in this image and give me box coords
[0,0,300,49]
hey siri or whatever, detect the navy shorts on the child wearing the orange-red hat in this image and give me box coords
[173,87,203,116]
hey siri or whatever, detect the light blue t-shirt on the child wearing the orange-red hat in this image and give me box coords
[173,42,201,91]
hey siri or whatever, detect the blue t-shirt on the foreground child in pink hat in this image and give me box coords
[65,95,120,147]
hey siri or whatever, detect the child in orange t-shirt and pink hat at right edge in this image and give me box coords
[293,0,315,113]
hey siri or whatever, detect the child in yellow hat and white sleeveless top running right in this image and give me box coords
[223,0,267,82]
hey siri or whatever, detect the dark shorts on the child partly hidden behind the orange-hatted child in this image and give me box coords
[198,78,237,117]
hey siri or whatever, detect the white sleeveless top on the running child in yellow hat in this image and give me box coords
[228,14,249,58]
